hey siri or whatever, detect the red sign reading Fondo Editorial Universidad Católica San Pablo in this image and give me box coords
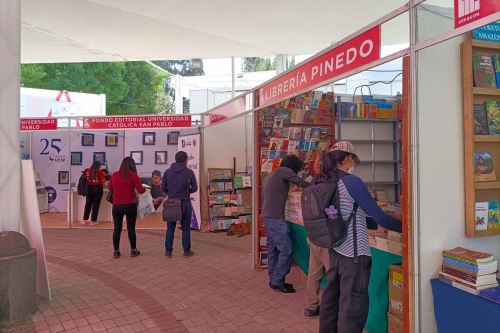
[83,115,191,129]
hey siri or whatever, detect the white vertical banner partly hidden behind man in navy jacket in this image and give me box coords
[177,134,203,229]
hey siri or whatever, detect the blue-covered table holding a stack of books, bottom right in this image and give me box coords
[431,247,500,333]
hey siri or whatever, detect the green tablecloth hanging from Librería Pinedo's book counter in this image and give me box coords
[288,222,402,333]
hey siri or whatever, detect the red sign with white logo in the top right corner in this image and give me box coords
[455,0,500,28]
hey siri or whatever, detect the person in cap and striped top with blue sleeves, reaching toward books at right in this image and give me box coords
[319,141,401,333]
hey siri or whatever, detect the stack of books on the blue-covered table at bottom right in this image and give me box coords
[439,247,498,295]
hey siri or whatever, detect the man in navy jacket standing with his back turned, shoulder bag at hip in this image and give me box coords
[161,151,198,258]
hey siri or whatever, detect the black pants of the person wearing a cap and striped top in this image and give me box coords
[319,250,372,333]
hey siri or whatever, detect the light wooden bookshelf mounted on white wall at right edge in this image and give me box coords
[461,39,500,237]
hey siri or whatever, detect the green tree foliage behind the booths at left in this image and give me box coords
[21,62,173,115]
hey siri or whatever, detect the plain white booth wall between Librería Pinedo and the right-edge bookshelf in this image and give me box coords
[416,37,500,332]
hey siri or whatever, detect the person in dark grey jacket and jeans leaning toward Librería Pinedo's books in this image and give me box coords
[262,155,309,293]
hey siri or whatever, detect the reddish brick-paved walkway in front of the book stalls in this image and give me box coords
[0,229,318,333]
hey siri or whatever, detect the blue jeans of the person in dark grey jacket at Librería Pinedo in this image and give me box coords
[264,217,292,287]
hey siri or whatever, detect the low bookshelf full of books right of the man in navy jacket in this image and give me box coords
[208,168,252,231]
